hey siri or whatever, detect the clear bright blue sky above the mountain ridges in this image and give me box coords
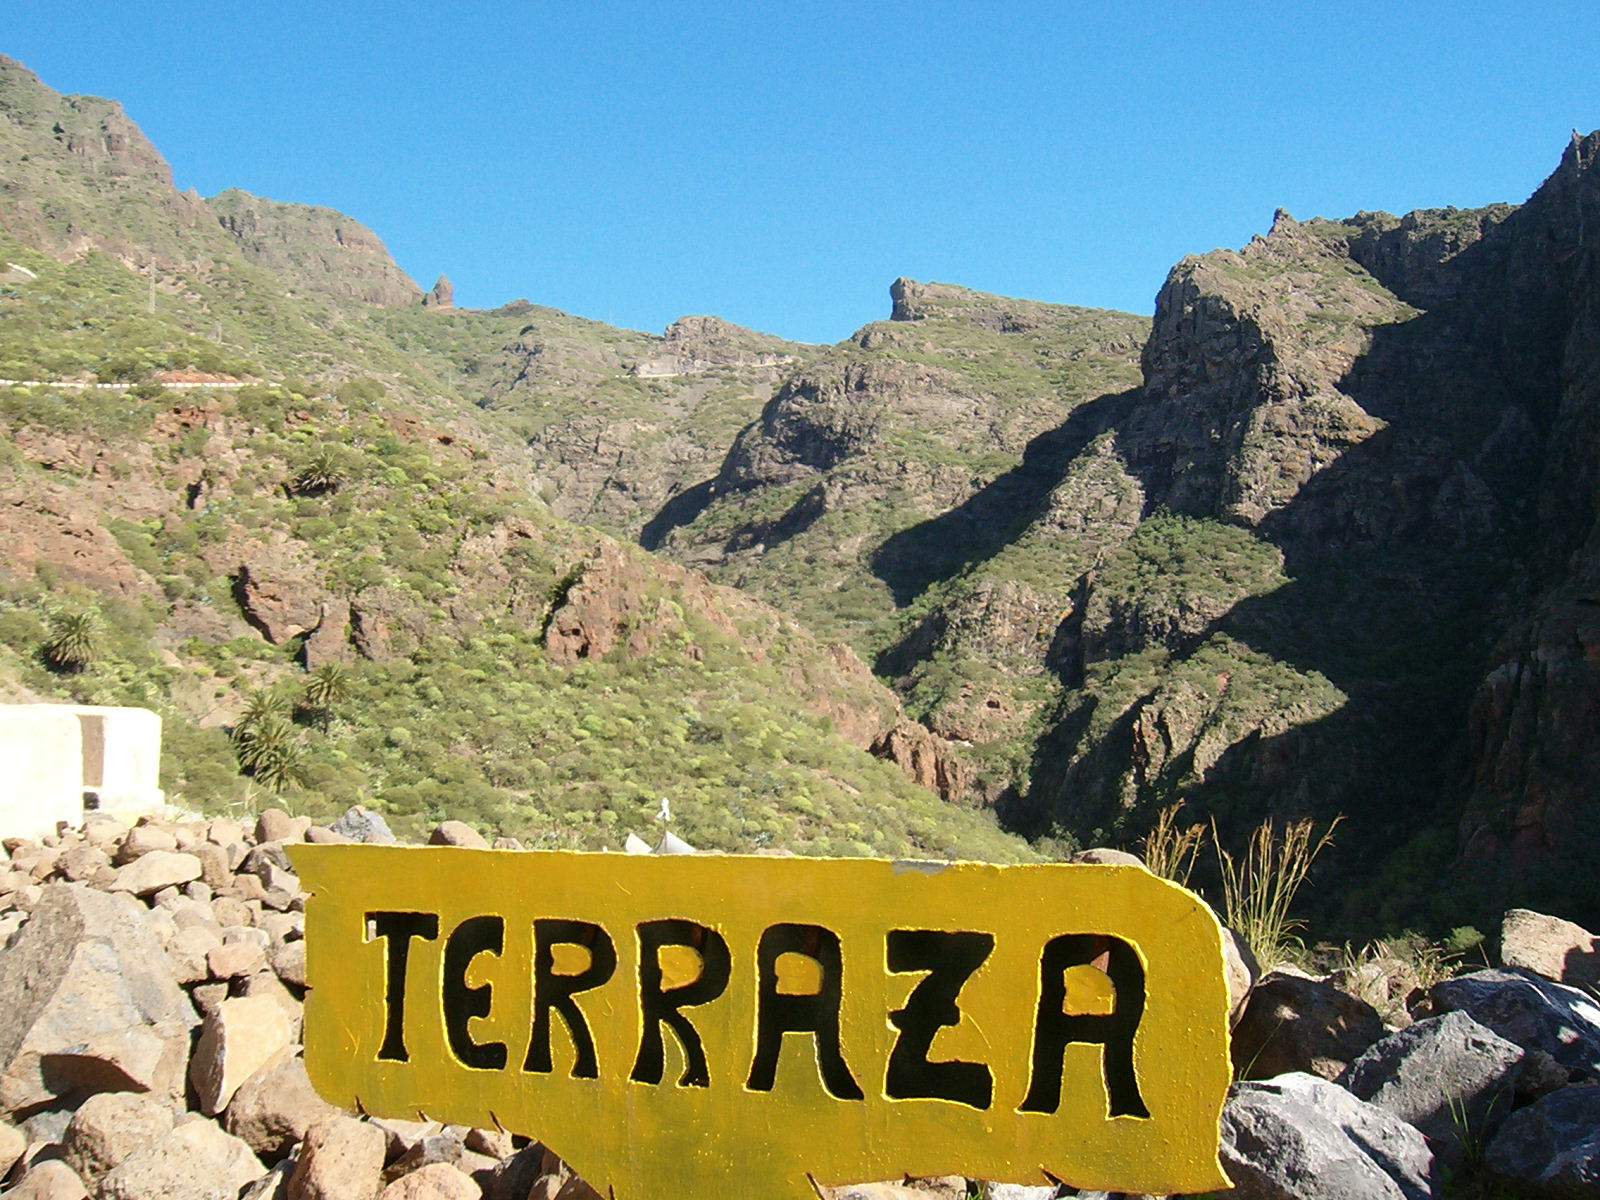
[0,0,1600,341]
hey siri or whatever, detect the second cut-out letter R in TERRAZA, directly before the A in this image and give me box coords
[629,918,733,1088]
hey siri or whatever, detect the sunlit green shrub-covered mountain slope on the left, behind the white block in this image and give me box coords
[0,61,1029,859]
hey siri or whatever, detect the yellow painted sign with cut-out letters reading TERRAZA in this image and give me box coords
[290,845,1229,1200]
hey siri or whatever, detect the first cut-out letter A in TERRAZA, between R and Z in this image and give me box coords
[744,923,862,1099]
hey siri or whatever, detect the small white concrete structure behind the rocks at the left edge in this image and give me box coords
[0,704,166,838]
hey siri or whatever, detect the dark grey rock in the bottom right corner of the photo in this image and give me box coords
[1483,1088,1600,1200]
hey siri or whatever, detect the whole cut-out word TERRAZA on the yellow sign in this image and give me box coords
[366,912,1150,1117]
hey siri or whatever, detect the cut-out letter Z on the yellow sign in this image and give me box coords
[883,930,995,1109]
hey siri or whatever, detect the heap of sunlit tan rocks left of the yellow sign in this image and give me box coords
[0,808,597,1200]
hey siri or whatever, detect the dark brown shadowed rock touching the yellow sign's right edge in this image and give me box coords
[1232,971,1384,1080]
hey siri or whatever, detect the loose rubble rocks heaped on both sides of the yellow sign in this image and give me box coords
[0,808,1600,1200]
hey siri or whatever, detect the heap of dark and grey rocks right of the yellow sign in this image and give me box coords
[1203,909,1600,1200]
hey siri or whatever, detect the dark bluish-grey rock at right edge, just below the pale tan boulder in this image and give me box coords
[1429,966,1600,1075]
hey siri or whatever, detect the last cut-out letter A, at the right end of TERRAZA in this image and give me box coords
[1019,933,1150,1117]
